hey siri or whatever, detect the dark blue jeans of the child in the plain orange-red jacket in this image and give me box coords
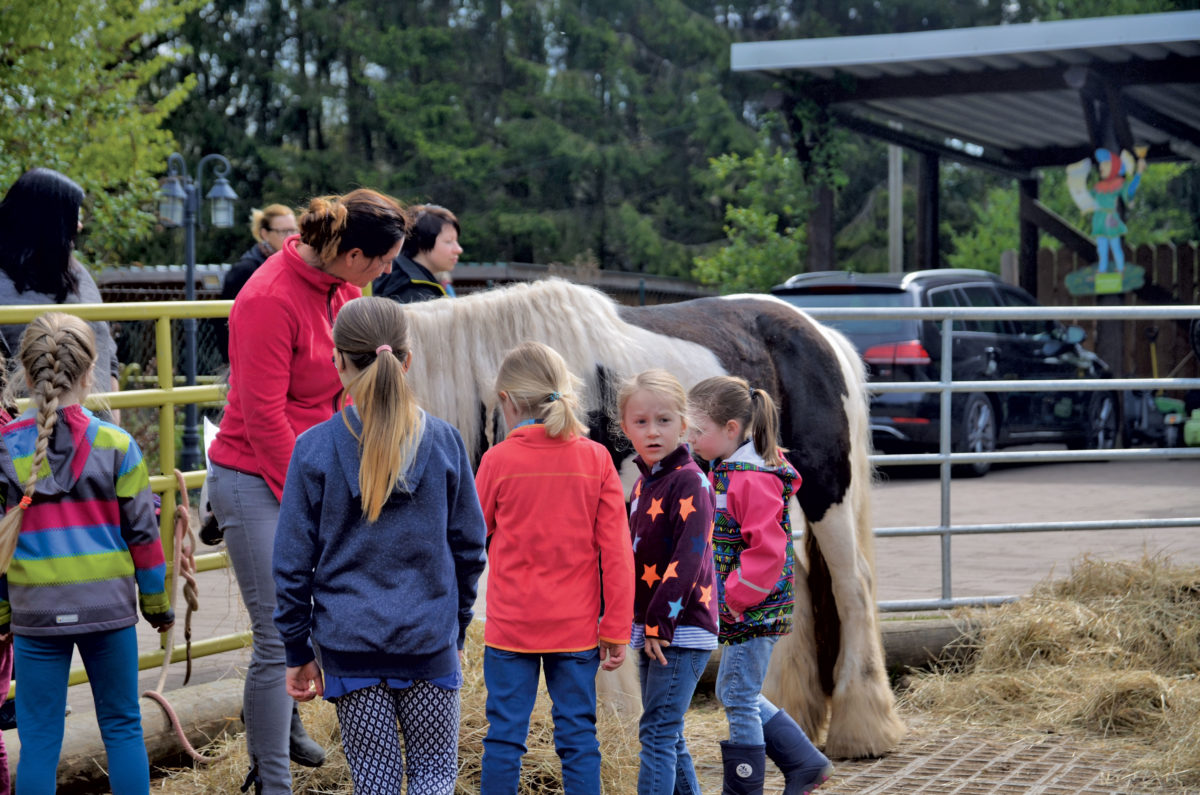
[482,646,600,795]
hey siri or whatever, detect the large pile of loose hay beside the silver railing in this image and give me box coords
[901,556,1200,788]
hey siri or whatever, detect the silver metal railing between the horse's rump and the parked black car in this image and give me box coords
[805,306,1200,612]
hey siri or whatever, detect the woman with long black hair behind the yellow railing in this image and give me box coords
[0,168,120,391]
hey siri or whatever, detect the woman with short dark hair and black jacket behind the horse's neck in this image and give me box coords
[372,204,462,304]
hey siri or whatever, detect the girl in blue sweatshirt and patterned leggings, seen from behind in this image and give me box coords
[274,298,486,795]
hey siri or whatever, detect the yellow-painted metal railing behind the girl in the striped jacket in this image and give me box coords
[0,301,243,685]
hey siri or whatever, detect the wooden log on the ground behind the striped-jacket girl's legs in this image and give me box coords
[4,679,244,788]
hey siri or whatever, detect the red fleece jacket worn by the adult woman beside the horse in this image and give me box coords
[209,235,362,498]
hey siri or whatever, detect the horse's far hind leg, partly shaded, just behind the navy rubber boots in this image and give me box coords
[762,500,828,741]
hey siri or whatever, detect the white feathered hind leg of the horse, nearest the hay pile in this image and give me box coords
[811,504,905,757]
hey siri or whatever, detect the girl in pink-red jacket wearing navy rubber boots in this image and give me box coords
[688,376,833,795]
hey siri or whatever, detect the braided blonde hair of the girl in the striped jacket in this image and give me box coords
[0,312,96,572]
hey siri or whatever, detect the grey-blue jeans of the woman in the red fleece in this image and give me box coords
[205,464,293,795]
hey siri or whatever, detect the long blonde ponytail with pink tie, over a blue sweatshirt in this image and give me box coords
[334,298,421,521]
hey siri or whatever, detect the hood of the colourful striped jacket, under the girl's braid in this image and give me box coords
[0,404,100,495]
